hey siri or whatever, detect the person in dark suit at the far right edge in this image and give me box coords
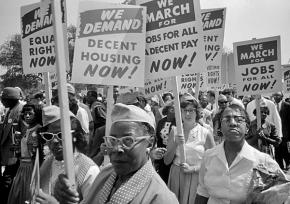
[272,92,290,170]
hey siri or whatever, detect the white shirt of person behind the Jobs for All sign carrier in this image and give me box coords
[247,97,283,138]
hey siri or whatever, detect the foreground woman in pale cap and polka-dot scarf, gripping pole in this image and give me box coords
[52,103,178,204]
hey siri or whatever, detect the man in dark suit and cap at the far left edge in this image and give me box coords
[0,87,23,203]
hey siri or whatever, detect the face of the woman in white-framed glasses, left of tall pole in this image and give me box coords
[46,120,63,161]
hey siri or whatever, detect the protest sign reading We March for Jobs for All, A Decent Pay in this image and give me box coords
[136,0,206,79]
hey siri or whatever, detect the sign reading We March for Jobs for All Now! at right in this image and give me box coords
[234,36,282,95]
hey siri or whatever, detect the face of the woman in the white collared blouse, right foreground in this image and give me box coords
[221,107,248,142]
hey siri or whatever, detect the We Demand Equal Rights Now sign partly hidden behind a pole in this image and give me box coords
[21,1,66,74]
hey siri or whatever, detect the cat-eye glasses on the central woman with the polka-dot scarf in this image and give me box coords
[104,136,150,149]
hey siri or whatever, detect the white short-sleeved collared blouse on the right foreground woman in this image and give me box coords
[197,141,283,204]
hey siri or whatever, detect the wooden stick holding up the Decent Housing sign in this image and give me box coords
[103,86,114,166]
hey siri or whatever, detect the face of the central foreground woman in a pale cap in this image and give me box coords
[109,122,148,175]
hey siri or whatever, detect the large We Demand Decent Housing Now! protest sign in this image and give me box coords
[72,2,146,87]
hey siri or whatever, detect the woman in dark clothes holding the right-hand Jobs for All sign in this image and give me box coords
[246,102,281,158]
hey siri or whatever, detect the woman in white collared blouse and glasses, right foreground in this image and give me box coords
[195,104,283,204]
